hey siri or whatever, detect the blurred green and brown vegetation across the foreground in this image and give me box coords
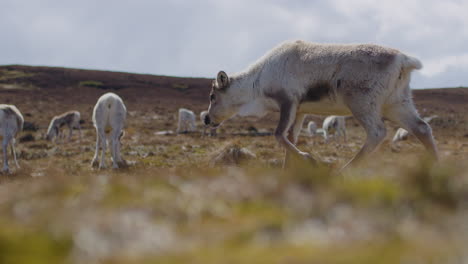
[0,157,468,264]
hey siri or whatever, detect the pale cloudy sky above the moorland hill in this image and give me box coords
[0,0,468,88]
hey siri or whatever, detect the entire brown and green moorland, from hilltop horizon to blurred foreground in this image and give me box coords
[0,66,468,264]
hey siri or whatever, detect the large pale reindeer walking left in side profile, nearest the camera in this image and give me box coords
[205,41,437,166]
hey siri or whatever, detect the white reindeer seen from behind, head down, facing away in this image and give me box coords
[92,93,127,168]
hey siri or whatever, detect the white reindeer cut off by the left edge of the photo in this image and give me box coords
[0,104,24,173]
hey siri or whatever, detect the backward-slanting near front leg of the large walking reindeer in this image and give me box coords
[275,102,313,167]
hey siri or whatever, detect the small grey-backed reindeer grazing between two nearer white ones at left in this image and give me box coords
[46,111,82,141]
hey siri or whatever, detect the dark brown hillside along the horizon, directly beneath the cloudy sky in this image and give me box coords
[0,65,468,107]
